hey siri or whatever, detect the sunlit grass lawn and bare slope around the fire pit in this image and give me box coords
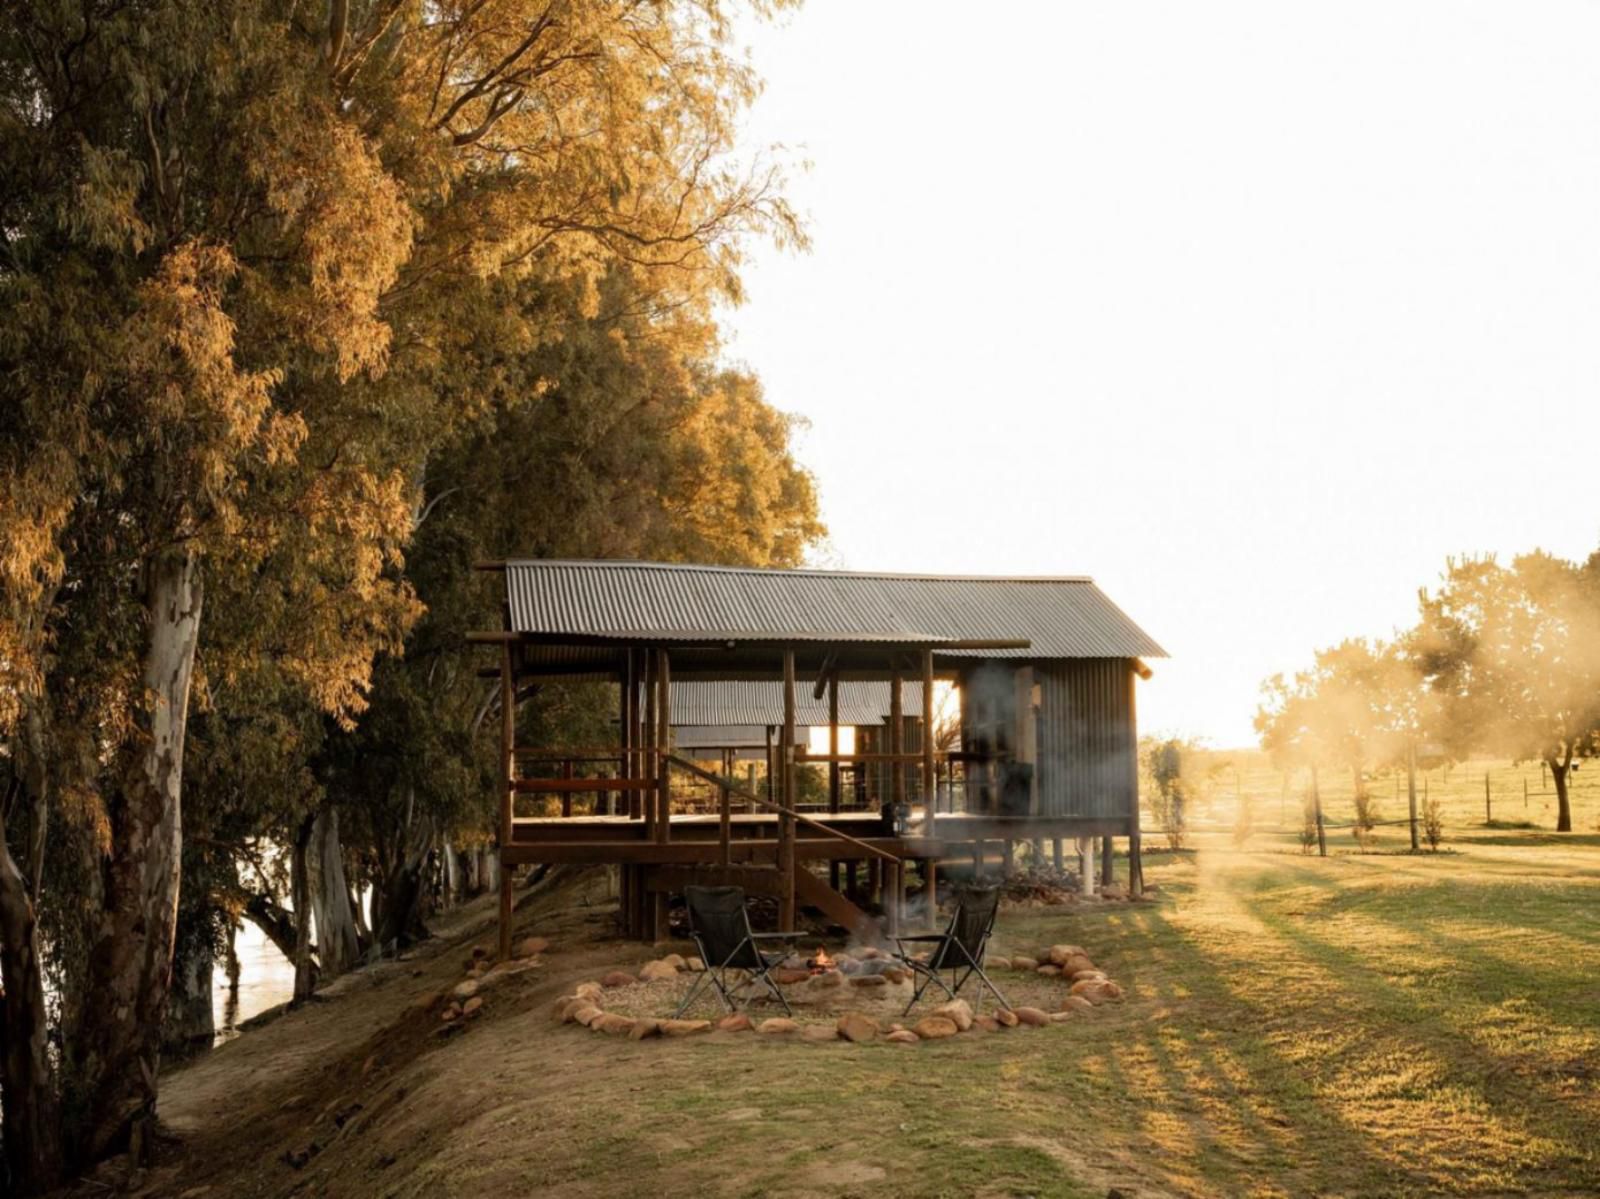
[156,831,1600,1199]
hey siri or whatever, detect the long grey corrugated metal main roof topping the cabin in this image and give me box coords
[506,559,1166,658]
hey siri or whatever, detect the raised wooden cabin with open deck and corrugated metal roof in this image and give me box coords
[472,560,1165,952]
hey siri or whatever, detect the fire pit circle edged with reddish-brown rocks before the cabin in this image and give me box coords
[550,944,1123,1045]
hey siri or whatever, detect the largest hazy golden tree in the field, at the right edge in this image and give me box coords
[1413,551,1600,832]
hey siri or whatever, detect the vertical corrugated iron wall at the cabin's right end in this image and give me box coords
[1034,658,1139,816]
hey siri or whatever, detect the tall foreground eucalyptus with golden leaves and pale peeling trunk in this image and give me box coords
[0,0,798,1189]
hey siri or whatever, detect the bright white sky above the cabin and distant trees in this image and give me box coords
[728,0,1600,746]
